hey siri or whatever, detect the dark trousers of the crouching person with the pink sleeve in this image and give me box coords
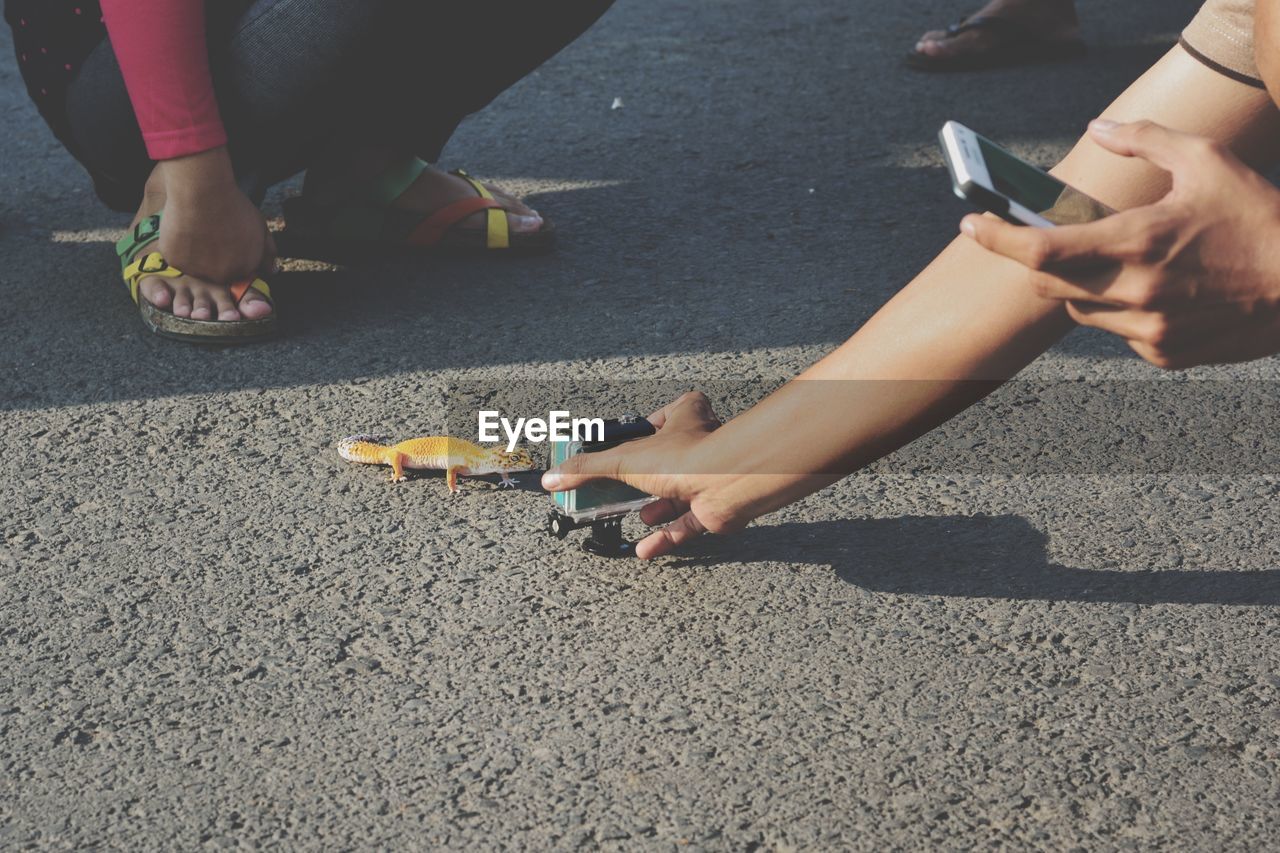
[67,0,612,211]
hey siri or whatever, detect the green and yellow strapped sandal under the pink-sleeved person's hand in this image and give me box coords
[115,214,275,343]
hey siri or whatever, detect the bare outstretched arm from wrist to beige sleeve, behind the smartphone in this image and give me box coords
[704,47,1280,517]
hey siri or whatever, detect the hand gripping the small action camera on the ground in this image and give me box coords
[543,391,751,560]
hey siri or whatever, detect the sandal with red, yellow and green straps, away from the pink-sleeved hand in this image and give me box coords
[280,158,556,260]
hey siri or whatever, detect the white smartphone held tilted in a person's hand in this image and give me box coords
[938,122,1115,228]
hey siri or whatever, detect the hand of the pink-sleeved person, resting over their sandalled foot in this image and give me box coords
[160,149,276,284]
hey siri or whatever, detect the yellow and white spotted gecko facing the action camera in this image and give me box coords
[338,435,538,492]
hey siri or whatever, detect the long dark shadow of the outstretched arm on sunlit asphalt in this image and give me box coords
[675,515,1280,606]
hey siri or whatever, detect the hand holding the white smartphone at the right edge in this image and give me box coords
[960,120,1280,369]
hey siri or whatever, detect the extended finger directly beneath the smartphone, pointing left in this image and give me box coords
[960,205,1157,270]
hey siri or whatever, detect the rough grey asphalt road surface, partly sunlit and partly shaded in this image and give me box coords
[0,0,1280,850]
